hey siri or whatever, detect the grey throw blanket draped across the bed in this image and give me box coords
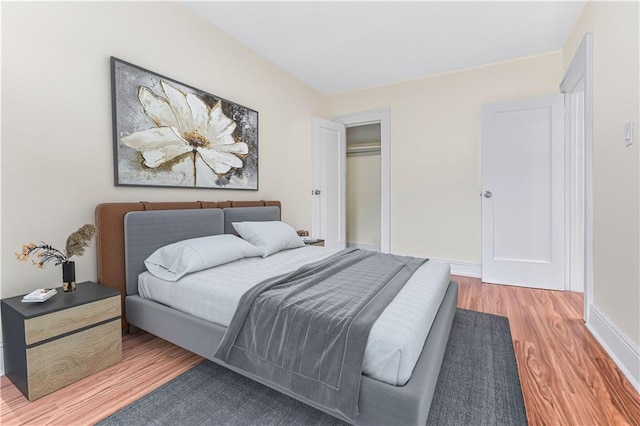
[215,249,425,422]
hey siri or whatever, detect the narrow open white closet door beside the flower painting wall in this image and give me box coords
[311,117,347,248]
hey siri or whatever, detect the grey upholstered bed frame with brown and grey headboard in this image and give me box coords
[96,202,457,424]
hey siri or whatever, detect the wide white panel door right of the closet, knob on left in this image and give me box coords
[481,94,565,290]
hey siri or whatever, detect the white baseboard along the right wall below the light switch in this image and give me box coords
[587,305,640,392]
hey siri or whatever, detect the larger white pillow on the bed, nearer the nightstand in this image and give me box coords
[144,234,262,281]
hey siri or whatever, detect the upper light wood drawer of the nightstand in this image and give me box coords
[24,296,120,345]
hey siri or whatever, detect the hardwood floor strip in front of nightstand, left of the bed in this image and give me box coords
[0,333,202,426]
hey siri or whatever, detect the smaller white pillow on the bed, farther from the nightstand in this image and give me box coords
[232,221,304,257]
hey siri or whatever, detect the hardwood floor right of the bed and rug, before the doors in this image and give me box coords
[453,277,640,425]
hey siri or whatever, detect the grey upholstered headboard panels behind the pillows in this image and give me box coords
[124,206,280,295]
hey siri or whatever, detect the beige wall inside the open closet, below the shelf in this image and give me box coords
[347,155,380,247]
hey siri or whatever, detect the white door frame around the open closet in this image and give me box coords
[333,109,391,253]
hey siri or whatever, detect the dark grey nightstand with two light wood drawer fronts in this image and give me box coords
[2,282,122,401]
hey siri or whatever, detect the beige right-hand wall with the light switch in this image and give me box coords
[562,2,640,345]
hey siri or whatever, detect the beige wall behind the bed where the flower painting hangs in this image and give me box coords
[1,2,326,297]
